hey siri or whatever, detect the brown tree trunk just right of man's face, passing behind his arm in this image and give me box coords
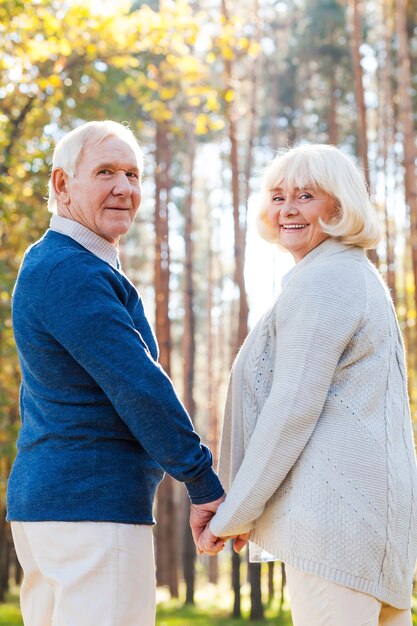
[154,123,178,598]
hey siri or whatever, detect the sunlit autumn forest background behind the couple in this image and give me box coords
[0,0,417,626]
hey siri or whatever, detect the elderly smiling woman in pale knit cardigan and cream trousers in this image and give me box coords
[199,145,417,626]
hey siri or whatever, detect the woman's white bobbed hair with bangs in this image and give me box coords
[257,144,381,248]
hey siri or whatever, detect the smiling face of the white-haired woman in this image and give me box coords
[267,187,336,263]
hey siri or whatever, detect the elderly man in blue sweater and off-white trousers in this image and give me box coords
[8,121,223,626]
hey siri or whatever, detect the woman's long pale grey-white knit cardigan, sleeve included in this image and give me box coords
[211,239,417,609]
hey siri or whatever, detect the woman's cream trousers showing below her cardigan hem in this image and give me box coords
[285,565,412,626]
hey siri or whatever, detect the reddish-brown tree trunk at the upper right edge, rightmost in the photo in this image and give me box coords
[395,0,417,307]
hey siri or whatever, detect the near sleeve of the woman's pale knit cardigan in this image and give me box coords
[210,264,365,536]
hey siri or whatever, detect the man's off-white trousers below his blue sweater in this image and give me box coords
[12,522,155,626]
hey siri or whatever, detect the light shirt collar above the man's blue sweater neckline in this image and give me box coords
[49,215,120,269]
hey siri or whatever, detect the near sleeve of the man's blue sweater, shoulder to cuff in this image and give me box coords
[44,253,223,504]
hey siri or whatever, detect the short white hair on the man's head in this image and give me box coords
[48,120,143,213]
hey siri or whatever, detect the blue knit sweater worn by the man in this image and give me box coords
[7,231,223,524]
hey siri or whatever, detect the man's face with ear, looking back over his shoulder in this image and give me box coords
[58,137,141,245]
